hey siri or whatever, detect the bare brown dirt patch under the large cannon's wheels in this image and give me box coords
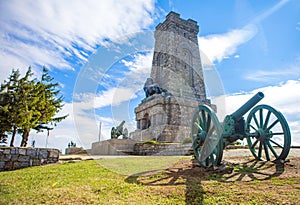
[165,157,300,181]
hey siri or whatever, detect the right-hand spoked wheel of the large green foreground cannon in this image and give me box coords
[246,105,291,161]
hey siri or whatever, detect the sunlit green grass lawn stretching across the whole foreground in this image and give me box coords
[0,157,300,204]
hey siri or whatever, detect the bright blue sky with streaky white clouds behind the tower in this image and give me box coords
[0,0,300,149]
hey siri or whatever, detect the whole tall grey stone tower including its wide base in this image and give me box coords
[132,12,210,142]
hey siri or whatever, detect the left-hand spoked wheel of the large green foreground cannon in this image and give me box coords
[191,105,223,167]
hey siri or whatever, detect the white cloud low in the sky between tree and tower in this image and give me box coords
[4,52,152,150]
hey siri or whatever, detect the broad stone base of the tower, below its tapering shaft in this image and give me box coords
[130,95,209,142]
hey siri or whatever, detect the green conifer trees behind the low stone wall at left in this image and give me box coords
[0,67,67,147]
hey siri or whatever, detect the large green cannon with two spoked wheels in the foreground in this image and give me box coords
[191,92,291,167]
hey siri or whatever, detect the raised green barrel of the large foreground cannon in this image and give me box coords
[231,92,264,121]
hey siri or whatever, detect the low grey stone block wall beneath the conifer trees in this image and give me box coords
[0,147,59,171]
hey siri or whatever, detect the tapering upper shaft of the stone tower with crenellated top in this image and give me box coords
[151,12,206,101]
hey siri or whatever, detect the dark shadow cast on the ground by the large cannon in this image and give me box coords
[125,160,284,204]
